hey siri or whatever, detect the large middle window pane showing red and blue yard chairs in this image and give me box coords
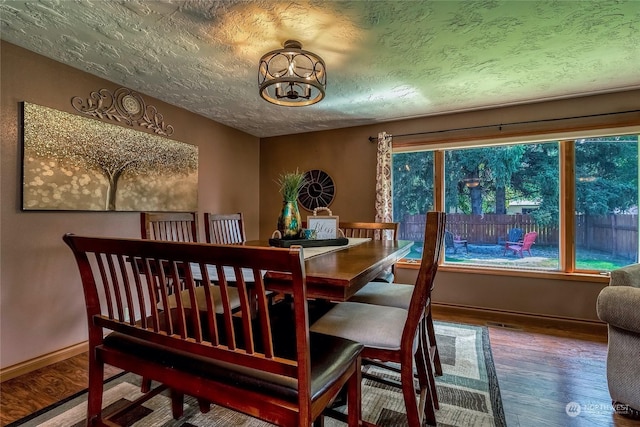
[445,142,559,270]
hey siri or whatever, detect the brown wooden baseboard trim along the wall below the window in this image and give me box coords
[432,302,607,338]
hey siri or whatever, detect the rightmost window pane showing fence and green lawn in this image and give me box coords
[575,135,638,271]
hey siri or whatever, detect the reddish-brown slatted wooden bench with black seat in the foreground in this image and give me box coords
[64,234,362,427]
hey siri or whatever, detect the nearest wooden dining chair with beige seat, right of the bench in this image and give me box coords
[311,212,445,427]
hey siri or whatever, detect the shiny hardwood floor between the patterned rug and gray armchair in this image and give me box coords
[433,307,640,427]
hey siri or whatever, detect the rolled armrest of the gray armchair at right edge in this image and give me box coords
[596,286,640,333]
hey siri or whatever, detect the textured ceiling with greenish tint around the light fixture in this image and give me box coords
[0,0,640,137]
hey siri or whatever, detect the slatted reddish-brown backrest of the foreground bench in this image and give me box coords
[64,234,310,401]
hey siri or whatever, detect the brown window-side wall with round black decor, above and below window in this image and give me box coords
[260,90,640,321]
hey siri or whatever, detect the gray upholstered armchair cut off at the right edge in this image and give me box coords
[597,264,640,418]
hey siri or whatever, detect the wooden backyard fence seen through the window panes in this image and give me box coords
[398,214,638,259]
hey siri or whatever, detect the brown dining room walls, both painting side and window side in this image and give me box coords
[0,41,640,370]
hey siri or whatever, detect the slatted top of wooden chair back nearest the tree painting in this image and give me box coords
[140,212,199,242]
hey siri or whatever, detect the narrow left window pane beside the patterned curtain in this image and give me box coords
[393,151,433,259]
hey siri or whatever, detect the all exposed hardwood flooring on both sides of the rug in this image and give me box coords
[0,307,640,427]
